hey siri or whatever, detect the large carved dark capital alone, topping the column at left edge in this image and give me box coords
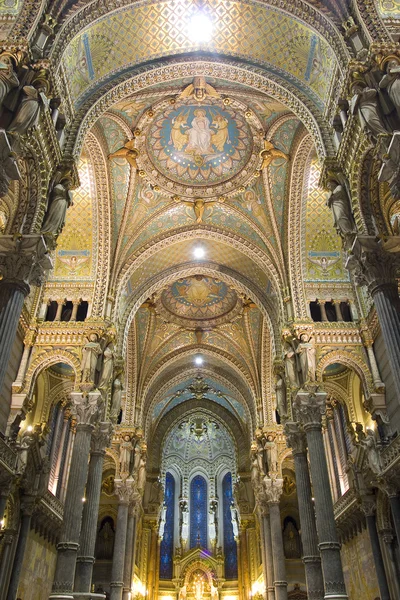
[0,235,53,295]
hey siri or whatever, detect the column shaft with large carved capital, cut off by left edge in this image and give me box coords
[0,235,52,388]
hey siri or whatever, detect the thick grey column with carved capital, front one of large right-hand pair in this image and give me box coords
[294,389,347,600]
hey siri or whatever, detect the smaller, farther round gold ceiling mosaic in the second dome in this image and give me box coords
[160,275,241,328]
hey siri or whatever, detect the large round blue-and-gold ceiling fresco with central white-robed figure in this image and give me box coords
[147,104,252,186]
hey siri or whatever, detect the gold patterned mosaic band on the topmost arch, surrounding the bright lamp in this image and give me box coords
[61,0,336,105]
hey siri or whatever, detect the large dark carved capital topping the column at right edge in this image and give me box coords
[346,235,400,295]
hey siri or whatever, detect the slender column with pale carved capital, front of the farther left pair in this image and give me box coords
[110,478,133,600]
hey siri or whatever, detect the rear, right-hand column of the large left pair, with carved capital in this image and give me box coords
[74,423,112,592]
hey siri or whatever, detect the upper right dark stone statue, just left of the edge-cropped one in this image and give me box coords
[350,81,389,141]
